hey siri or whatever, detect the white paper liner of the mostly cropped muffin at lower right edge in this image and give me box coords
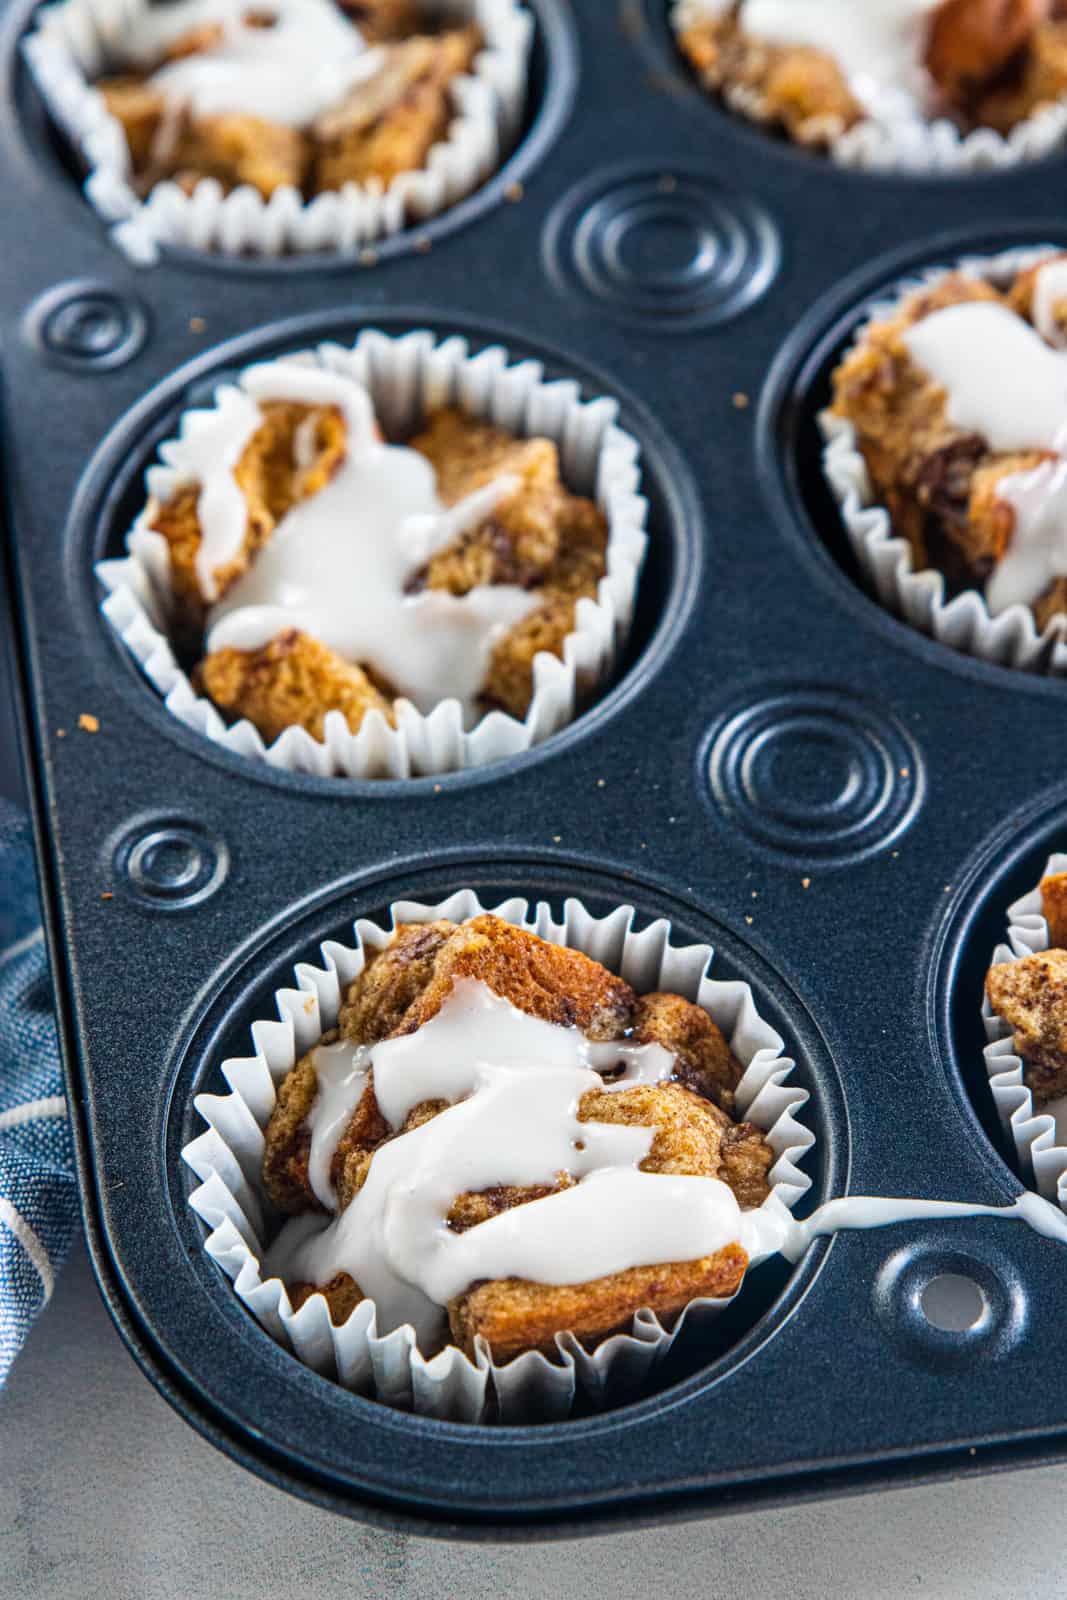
[982,853,1067,1211]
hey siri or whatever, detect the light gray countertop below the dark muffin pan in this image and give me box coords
[0,1246,1067,1600]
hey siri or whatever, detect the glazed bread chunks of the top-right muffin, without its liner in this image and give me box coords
[673,0,1067,165]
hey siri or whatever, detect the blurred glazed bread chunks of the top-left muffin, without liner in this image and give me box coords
[96,0,483,198]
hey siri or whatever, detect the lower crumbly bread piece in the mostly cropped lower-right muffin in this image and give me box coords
[985,949,1067,1106]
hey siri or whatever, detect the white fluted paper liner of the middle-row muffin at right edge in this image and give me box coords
[819,245,1067,675]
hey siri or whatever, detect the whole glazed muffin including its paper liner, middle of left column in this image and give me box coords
[98,330,648,778]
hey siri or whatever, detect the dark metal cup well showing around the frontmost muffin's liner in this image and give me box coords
[165,856,849,1451]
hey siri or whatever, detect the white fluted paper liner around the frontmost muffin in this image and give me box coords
[182,890,814,1422]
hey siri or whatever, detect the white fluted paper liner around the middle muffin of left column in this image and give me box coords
[96,328,648,778]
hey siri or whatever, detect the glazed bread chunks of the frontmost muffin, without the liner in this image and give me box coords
[262,915,774,1360]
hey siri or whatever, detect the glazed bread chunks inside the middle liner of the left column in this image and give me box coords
[134,362,608,739]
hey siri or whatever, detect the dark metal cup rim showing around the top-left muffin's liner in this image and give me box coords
[3,0,579,277]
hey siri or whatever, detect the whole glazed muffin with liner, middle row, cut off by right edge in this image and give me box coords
[821,250,1067,670]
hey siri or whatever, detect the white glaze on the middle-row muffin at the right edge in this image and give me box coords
[904,294,1067,616]
